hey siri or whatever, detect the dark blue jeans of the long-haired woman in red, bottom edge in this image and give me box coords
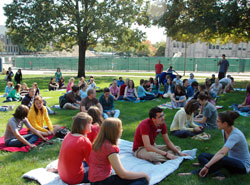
[91,175,148,185]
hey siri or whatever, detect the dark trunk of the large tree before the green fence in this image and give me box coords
[77,40,87,78]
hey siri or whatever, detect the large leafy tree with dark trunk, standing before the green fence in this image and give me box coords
[4,0,149,77]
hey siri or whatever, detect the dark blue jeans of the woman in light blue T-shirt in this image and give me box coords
[193,153,246,174]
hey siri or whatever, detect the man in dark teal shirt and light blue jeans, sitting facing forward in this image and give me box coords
[99,87,120,119]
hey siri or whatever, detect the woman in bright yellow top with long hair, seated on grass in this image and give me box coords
[28,96,61,136]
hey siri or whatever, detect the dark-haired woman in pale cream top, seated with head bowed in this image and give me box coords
[170,99,203,138]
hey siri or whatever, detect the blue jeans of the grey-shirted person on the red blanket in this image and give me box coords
[5,134,38,147]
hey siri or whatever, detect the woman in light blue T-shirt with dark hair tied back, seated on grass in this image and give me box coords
[179,111,250,180]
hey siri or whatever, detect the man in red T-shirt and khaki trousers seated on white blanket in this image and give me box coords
[133,107,186,162]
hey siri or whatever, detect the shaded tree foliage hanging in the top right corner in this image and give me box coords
[154,0,250,43]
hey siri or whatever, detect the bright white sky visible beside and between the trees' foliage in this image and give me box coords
[0,0,166,44]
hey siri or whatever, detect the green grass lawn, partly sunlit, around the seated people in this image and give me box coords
[0,73,250,185]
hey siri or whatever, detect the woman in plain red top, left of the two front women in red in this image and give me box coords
[58,112,92,184]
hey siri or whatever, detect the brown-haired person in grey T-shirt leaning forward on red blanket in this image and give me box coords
[4,105,48,148]
